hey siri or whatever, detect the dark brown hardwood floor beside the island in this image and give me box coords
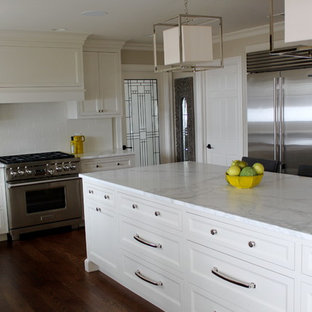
[0,229,165,312]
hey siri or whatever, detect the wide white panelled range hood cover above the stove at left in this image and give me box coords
[0,31,86,103]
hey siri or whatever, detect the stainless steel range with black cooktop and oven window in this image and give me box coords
[0,152,83,240]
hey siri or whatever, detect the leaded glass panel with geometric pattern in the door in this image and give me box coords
[124,79,159,166]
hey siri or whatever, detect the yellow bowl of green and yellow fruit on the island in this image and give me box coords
[225,160,264,188]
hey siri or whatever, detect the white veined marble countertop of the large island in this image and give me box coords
[81,162,312,239]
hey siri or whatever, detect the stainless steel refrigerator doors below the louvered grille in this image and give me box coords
[247,68,312,174]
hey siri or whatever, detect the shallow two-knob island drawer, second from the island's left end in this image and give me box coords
[119,193,182,230]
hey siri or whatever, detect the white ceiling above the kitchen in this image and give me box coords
[0,0,284,43]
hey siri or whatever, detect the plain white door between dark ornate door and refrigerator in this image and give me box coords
[198,57,243,165]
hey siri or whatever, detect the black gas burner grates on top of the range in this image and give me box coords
[0,152,75,164]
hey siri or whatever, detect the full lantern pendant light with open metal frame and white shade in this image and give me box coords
[153,0,223,72]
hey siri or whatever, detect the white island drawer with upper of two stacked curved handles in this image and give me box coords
[120,218,181,269]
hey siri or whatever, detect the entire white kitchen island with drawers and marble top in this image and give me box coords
[81,162,312,312]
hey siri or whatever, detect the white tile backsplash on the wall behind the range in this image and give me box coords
[0,103,113,155]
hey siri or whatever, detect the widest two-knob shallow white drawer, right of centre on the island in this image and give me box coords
[186,213,295,269]
